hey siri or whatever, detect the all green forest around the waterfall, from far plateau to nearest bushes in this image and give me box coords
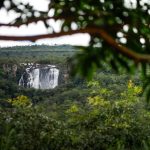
[0,45,150,150]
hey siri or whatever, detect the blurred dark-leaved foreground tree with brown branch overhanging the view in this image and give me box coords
[0,0,150,98]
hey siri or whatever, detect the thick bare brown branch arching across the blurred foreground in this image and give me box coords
[0,27,150,62]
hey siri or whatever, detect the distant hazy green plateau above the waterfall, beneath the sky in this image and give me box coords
[0,45,77,65]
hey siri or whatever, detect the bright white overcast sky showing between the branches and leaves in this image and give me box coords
[0,0,150,47]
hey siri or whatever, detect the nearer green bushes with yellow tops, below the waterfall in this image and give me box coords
[0,81,150,150]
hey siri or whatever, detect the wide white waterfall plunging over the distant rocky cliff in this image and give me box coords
[19,65,59,89]
